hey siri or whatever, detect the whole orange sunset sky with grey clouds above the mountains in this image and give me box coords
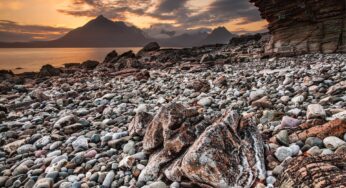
[0,0,267,42]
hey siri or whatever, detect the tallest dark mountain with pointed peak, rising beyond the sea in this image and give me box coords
[0,15,148,47]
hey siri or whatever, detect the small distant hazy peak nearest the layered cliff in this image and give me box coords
[200,27,235,45]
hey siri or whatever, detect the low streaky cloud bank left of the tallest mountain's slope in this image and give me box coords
[0,20,71,42]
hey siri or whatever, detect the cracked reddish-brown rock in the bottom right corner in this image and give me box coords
[278,154,346,188]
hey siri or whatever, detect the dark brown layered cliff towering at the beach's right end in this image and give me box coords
[250,0,346,54]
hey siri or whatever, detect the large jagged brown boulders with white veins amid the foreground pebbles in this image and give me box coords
[139,103,265,187]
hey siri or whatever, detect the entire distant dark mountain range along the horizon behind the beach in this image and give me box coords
[0,15,233,48]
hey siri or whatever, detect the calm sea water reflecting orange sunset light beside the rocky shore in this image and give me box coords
[0,48,141,73]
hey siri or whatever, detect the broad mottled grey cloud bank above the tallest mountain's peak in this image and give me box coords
[59,0,261,27]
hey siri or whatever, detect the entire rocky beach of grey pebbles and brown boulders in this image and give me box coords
[0,40,346,188]
